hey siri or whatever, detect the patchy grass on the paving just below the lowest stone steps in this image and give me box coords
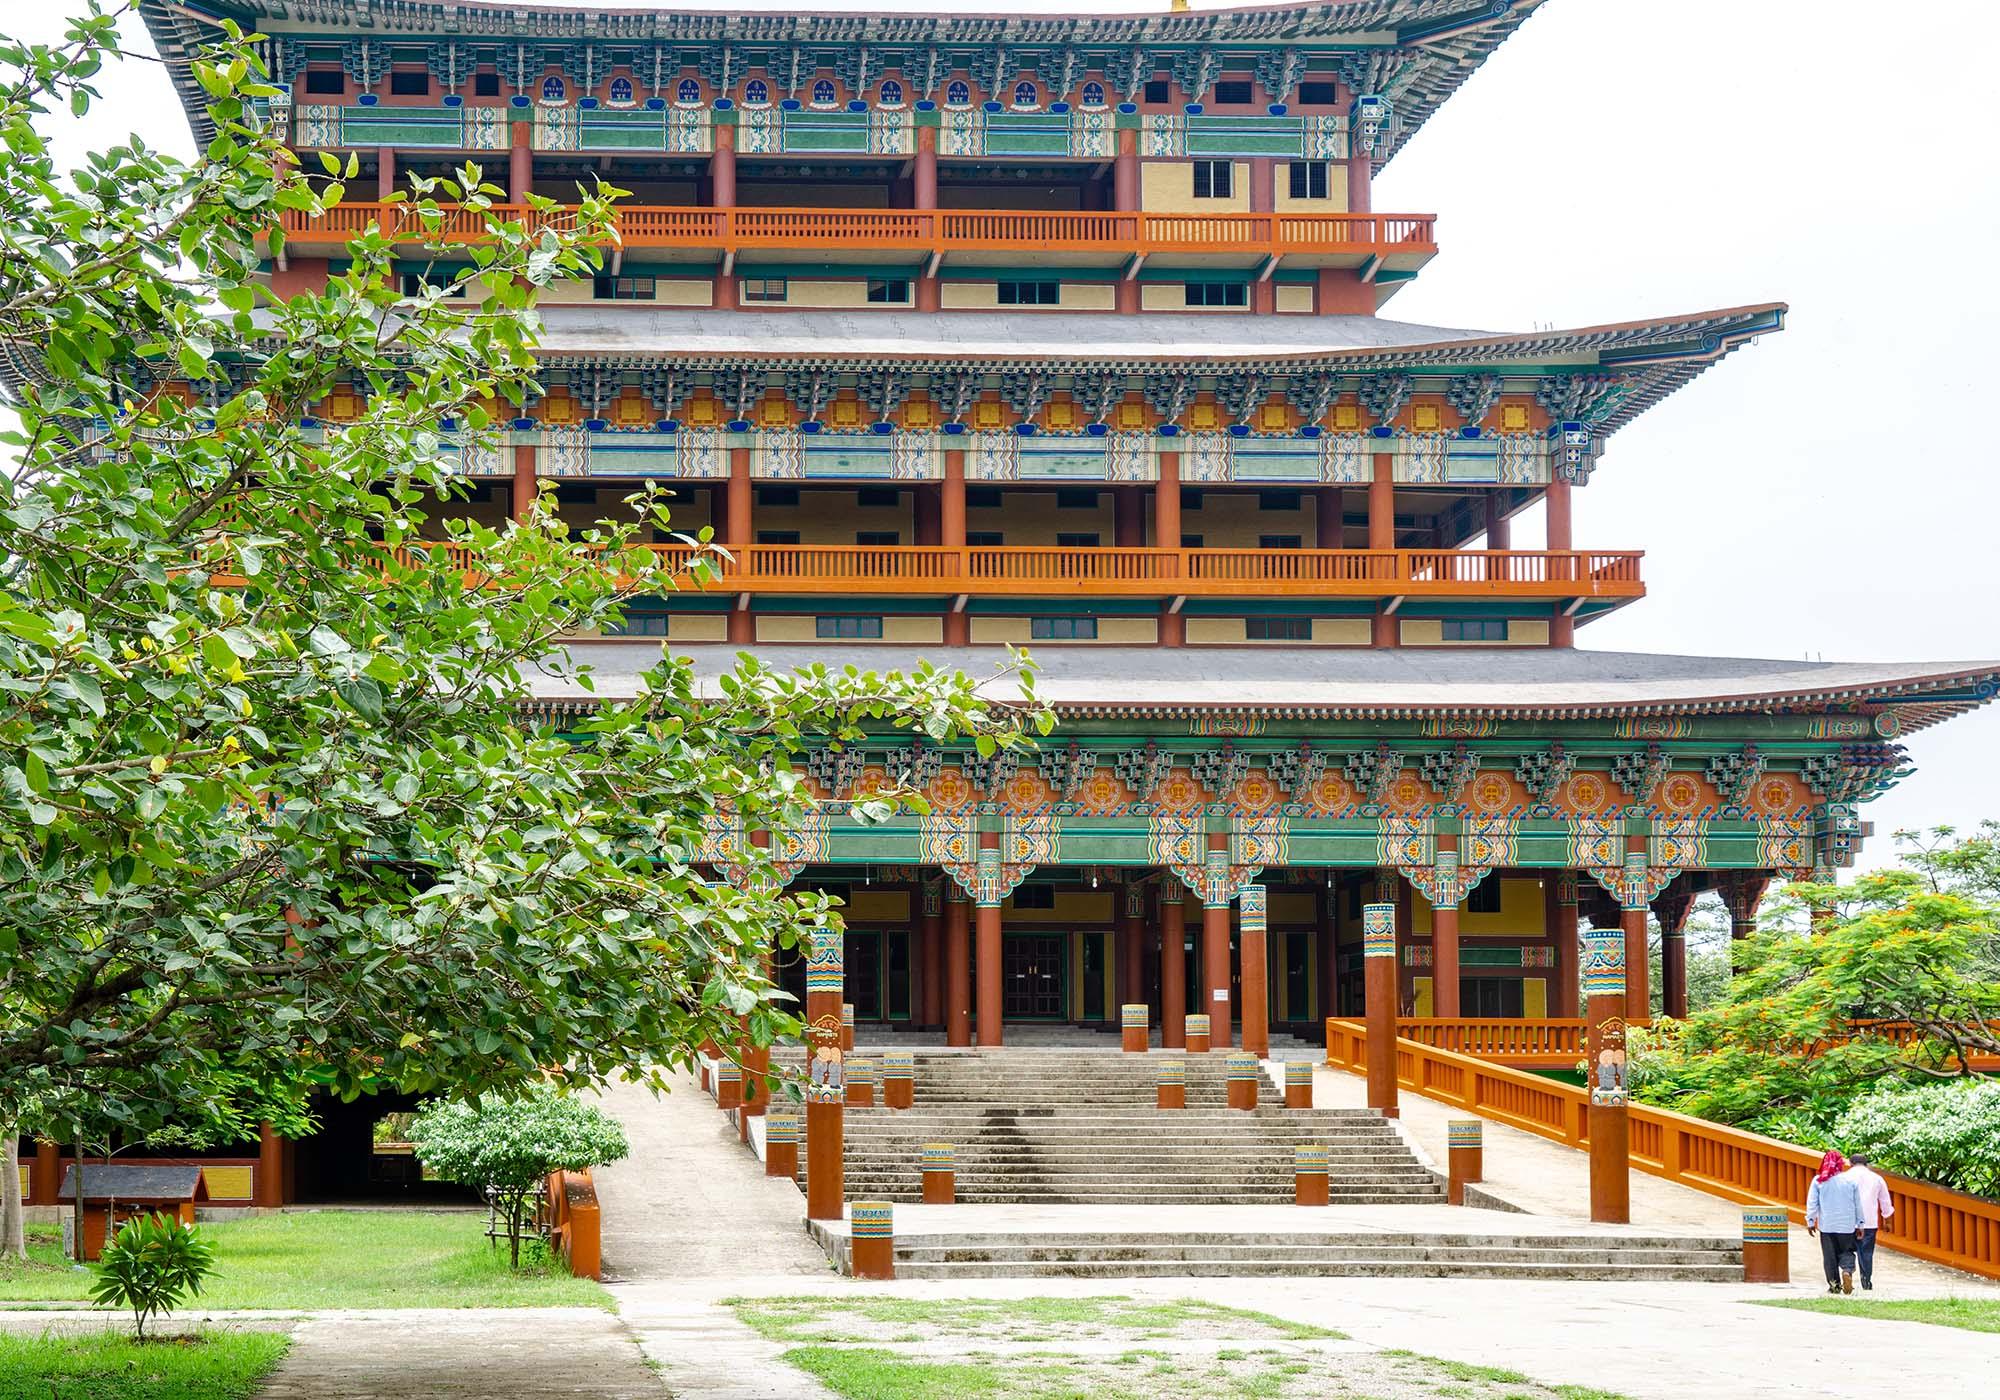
[724,1296,1342,1342]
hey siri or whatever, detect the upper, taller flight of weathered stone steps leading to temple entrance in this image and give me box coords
[800,1046,1444,1206]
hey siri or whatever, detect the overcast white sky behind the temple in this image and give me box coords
[15,0,2000,860]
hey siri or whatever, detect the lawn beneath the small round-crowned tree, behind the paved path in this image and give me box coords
[0,1210,612,1312]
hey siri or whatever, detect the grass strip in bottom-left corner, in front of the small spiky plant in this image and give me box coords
[0,1332,292,1400]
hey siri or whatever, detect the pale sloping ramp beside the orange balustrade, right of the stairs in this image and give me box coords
[1312,1066,2000,1296]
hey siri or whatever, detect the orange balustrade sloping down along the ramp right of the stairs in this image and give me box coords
[1326,1020,2000,1278]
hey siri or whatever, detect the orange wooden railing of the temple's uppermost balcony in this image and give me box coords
[284,204,1438,258]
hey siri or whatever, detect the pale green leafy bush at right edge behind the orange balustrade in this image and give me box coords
[1832,1080,2000,1198]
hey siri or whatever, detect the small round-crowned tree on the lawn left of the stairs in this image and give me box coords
[410,1088,630,1268]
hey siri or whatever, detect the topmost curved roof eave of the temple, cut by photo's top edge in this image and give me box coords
[140,0,1544,170]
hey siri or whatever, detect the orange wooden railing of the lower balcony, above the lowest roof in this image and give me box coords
[386,544,1646,598]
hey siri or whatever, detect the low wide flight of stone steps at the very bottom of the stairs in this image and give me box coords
[896,1232,1744,1282]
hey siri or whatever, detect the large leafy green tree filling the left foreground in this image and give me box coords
[0,0,1050,1248]
